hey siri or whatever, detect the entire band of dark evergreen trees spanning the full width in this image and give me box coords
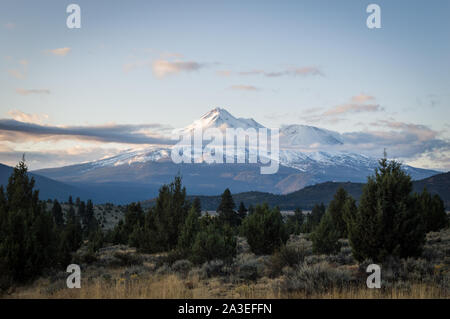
[0,158,448,289]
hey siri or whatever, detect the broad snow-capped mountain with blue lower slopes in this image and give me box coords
[36,108,438,202]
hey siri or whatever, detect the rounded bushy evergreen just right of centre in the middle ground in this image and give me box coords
[241,204,288,255]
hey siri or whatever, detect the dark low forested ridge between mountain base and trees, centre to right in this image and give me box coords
[144,172,450,210]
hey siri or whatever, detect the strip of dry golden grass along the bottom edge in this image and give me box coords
[4,274,449,299]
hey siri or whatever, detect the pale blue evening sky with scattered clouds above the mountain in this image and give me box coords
[0,0,450,171]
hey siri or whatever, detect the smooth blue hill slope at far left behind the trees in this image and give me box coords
[0,164,91,201]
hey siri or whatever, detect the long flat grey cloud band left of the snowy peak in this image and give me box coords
[0,119,174,145]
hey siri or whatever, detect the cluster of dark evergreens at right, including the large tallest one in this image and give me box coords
[312,158,448,262]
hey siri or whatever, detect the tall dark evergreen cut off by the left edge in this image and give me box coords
[0,159,57,282]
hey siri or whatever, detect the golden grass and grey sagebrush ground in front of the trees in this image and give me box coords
[0,229,450,299]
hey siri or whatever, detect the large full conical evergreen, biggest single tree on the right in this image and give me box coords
[346,156,425,262]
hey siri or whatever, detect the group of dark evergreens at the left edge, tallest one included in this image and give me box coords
[0,160,101,289]
